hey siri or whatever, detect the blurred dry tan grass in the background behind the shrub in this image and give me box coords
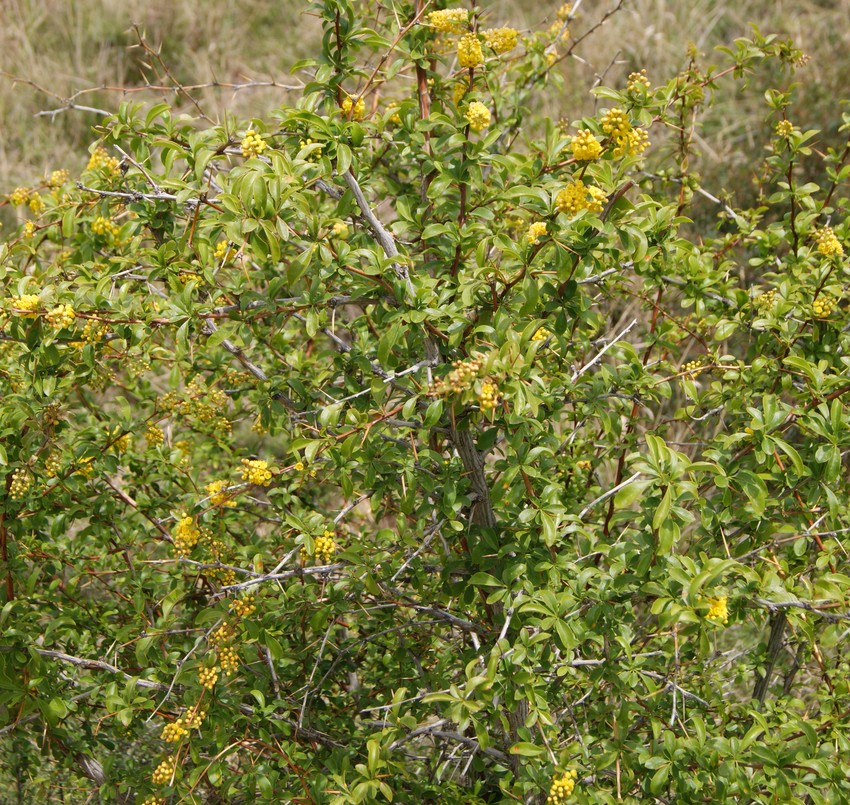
[0,0,850,207]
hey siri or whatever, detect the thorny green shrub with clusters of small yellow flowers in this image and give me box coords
[0,0,850,805]
